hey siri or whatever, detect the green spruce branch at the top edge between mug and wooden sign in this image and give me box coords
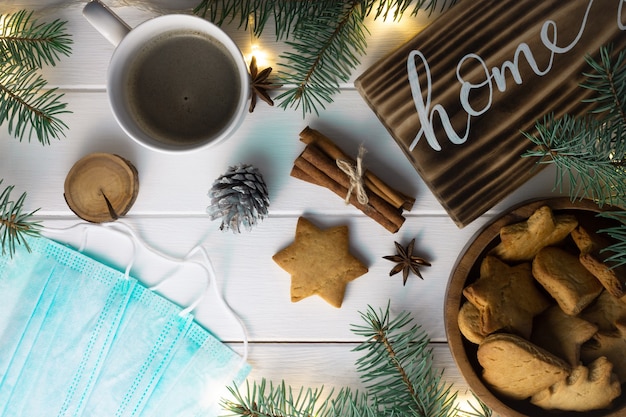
[194,0,456,115]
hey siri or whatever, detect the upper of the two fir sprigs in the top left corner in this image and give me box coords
[0,10,72,68]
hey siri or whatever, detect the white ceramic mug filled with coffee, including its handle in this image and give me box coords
[83,0,250,153]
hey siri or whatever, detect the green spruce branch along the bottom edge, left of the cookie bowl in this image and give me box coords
[222,305,458,417]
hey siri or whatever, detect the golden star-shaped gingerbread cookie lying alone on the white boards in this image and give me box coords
[272,217,367,308]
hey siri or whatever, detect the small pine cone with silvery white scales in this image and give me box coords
[207,164,270,233]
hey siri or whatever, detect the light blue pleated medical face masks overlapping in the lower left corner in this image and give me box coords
[0,228,250,417]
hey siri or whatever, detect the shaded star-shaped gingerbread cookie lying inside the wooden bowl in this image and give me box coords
[463,256,550,338]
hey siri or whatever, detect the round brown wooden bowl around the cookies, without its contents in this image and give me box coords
[444,198,626,417]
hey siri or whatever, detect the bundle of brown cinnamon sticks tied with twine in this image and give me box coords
[291,126,415,233]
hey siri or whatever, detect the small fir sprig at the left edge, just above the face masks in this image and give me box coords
[0,179,41,256]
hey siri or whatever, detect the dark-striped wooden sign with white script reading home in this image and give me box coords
[356,0,626,227]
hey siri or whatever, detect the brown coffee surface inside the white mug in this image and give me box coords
[124,30,242,146]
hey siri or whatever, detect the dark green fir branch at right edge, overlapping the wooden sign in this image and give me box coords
[522,46,626,207]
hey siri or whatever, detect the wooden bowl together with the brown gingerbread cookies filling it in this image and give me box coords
[445,198,626,417]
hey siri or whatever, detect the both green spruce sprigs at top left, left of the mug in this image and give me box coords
[0,10,72,145]
